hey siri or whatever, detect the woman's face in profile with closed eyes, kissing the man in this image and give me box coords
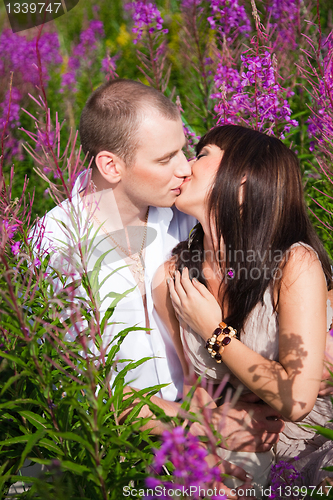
[175,145,223,222]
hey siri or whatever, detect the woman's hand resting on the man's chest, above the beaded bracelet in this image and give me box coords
[168,267,222,340]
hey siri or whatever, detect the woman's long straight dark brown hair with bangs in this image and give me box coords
[173,125,332,332]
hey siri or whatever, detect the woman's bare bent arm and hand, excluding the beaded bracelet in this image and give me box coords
[170,246,327,421]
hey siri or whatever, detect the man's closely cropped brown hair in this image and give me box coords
[80,79,180,167]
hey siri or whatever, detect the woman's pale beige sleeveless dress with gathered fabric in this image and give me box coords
[181,245,333,498]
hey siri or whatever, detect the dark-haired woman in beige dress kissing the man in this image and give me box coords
[153,125,333,496]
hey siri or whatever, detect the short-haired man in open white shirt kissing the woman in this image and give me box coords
[39,80,283,488]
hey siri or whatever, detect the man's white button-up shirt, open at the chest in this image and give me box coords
[39,175,196,401]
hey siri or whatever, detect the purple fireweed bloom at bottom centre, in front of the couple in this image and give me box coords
[142,375,244,500]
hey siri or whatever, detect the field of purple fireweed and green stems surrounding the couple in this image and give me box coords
[0,0,333,500]
